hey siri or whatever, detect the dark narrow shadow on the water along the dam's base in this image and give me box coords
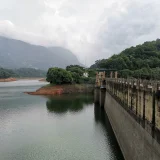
[94,104,124,160]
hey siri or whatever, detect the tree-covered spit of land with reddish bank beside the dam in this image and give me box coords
[25,65,96,95]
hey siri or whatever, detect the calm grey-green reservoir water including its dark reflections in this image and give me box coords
[0,80,124,160]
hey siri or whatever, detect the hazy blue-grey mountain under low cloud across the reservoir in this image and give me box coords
[0,36,80,70]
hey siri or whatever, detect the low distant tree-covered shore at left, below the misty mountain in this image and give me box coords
[0,68,46,78]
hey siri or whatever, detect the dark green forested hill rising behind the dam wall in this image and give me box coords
[91,39,160,79]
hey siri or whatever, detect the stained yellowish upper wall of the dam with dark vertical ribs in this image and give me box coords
[106,78,160,132]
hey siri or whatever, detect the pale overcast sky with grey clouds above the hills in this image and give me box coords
[0,0,160,65]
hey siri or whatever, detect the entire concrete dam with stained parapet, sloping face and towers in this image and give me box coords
[94,69,160,160]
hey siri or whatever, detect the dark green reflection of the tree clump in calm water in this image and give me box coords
[46,94,93,114]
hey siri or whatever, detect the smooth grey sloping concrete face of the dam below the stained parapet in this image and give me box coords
[104,92,160,160]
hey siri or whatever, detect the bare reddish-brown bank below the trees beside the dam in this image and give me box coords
[25,84,94,95]
